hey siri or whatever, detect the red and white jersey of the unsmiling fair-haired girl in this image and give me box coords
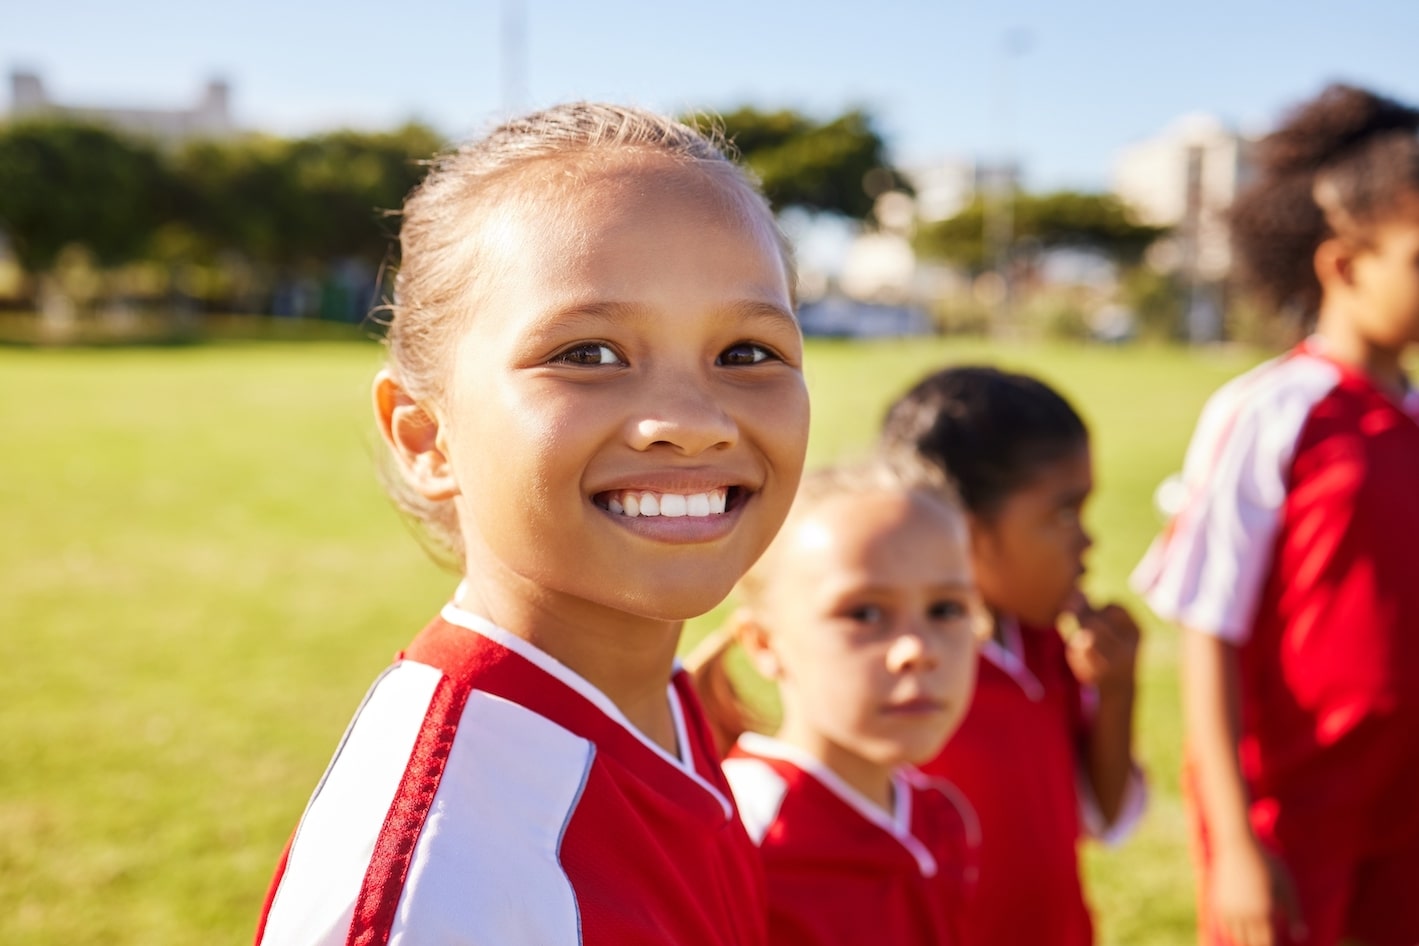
[724,733,981,946]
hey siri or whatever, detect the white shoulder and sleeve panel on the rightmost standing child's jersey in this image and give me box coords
[1132,353,1341,644]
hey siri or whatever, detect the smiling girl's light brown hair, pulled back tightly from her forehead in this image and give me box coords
[380,102,796,566]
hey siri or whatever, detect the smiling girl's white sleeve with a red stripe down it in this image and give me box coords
[258,661,596,946]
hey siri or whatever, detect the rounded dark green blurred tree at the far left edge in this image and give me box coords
[0,121,177,272]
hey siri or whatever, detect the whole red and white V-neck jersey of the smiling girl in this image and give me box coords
[257,606,766,946]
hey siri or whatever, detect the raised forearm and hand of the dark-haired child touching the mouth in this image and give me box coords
[1066,603,1139,825]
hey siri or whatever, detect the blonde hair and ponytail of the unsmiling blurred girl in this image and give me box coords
[684,452,966,753]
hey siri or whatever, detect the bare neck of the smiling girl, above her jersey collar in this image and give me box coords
[455,576,683,755]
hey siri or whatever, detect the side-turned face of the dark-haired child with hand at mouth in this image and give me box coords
[971,445,1094,627]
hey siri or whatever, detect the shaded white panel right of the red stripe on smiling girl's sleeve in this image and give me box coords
[389,691,596,946]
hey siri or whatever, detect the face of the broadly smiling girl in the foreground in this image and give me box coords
[438,155,809,623]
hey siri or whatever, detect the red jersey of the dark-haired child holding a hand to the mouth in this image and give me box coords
[922,618,1147,946]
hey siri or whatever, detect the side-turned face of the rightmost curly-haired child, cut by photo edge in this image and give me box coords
[1352,194,1419,350]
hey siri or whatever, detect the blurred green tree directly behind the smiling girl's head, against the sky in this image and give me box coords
[690,106,904,220]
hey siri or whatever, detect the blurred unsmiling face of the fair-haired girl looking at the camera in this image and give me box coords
[748,492,981,781]
